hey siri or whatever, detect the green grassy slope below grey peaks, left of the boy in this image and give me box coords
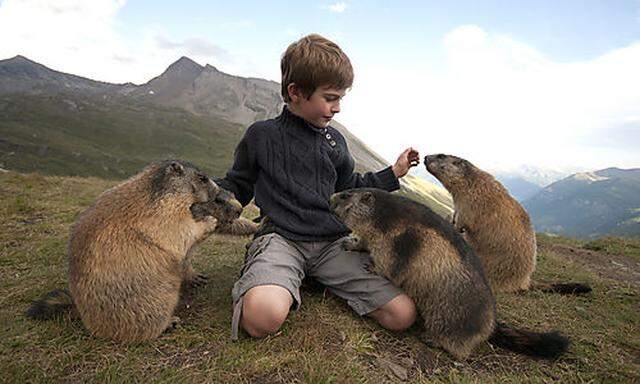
[0,95,244,179]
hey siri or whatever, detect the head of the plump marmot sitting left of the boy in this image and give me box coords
[151,160,220,203]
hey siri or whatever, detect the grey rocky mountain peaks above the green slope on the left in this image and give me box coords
[0,56,283,125]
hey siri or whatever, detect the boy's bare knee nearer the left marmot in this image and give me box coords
[241,285,293,337]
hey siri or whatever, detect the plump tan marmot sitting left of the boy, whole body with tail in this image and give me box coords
[27,160,242,342]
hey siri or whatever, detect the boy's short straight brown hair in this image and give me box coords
[280,34,353,102]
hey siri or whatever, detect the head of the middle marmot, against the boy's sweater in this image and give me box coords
[330,188,376,229]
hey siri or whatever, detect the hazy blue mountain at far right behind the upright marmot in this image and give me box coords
[524,168,640,238]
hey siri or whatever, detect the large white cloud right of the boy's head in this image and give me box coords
[338,26,640,172]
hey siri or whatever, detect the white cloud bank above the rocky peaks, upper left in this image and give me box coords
[0,0,262,83]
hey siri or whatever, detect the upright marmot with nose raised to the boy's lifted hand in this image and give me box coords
[425,154,591,293]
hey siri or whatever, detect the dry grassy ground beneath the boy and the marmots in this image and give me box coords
[0,172,640,383]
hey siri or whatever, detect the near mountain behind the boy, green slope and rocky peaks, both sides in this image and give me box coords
[0,56,452,216]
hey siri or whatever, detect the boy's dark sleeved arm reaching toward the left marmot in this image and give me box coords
[213,126,257,207]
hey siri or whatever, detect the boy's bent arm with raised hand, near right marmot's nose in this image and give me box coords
[336,144,420,192]
